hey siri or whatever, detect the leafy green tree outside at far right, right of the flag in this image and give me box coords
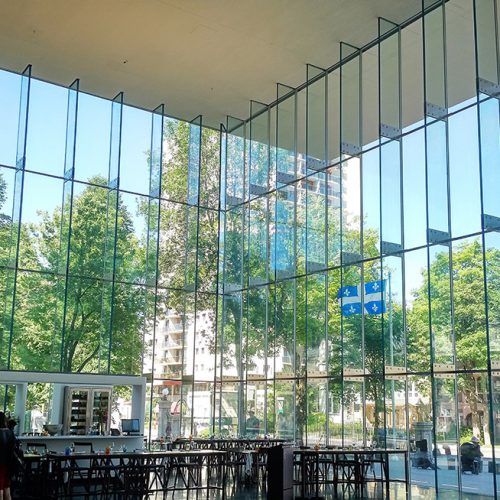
[408,240,494,443]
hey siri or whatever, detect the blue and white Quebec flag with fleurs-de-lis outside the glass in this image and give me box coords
[337,280,386,316]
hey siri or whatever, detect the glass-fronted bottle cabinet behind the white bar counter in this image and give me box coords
[64,387,112,435]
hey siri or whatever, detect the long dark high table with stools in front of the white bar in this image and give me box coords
[20,450,226,498]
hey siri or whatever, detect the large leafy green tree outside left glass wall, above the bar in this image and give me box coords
[12,178,146,373]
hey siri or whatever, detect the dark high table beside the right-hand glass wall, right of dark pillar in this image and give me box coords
[294,448,408,498]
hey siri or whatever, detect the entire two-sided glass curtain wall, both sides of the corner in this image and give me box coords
[0,0,500,497]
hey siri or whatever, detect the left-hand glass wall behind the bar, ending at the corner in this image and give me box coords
[0,67,221,438]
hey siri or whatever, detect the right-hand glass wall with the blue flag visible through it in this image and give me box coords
[219,0,500,496]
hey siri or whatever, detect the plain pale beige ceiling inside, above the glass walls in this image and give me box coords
[0,0,421,126]
